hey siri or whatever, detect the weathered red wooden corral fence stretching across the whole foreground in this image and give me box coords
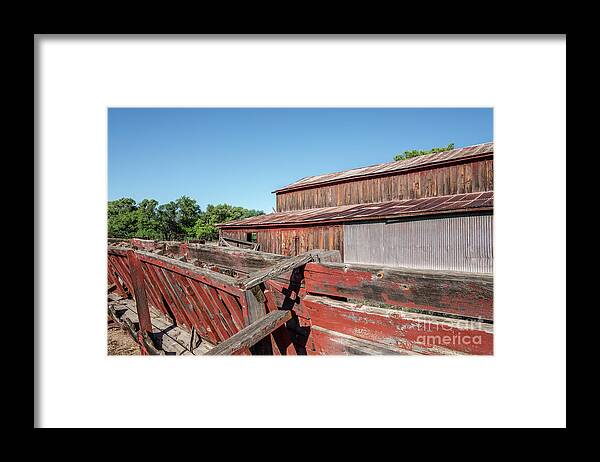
[108,241,493,355]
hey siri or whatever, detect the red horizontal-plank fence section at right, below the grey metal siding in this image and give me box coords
[295,263,493,355]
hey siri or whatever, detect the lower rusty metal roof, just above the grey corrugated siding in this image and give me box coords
[217,191,494,228]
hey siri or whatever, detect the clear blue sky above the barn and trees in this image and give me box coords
[108,108,493,213]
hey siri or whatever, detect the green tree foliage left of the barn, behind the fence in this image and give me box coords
[108,196,264,240]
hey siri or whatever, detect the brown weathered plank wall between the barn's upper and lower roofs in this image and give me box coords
[276,155,494,212]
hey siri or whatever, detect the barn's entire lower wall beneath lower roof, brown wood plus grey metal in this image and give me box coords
[221,213,493,273]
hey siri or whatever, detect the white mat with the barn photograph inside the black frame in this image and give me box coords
[33,34,567,433]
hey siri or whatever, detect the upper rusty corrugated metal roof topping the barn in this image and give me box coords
[273,142,494,193]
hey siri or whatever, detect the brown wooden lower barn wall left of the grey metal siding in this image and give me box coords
[221,224,344,258]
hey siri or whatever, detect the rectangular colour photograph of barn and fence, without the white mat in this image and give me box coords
[107,107,494,356]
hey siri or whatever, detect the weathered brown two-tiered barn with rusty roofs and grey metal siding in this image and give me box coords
[219,142,494,273]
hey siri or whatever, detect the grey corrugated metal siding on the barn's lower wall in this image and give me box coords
[344,215,493,273]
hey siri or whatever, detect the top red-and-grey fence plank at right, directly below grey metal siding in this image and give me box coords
[304,263,494,320]
